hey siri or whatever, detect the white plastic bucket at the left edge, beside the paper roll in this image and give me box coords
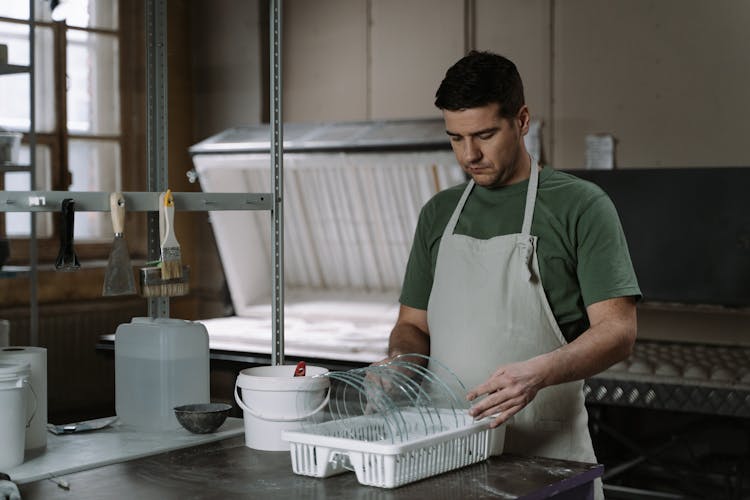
[0,362,31,471]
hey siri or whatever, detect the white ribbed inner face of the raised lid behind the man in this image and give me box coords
[193,146,462,316]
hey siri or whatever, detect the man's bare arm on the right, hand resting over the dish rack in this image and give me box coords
[467,297,637,427]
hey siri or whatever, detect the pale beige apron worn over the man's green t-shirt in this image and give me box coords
[427,159,602,498]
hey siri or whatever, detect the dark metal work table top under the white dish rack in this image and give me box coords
[19,436,603,500]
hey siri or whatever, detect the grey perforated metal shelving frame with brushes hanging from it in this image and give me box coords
[0,0,284,364]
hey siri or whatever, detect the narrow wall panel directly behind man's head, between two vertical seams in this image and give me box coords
[474,0,553,160]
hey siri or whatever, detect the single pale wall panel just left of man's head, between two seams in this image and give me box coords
[371,0,464,119]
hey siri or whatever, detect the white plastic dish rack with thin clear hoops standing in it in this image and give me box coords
[282,354,492,488]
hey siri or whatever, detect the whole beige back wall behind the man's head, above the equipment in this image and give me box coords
[193,0,750,168]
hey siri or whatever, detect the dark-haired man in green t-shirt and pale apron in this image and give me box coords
[389,51,640,495]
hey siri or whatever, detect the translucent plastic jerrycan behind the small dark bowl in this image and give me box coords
[115,318,211,431]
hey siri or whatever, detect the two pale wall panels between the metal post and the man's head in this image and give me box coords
[283,0,464,121]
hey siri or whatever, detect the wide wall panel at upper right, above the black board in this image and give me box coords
[553,0,750,167]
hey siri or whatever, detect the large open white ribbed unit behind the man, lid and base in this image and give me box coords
[190,119,464,362]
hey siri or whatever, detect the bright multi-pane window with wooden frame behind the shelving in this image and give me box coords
[0,0,123,246]
